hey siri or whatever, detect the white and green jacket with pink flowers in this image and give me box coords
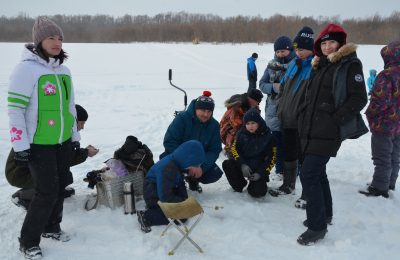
[8,46,80,152]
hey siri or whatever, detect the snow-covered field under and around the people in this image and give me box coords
[0,43,400,260]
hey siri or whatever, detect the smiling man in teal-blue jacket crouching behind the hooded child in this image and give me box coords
[160,91,222,193]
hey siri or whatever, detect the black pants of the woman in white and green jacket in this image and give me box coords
[20,140,72,248]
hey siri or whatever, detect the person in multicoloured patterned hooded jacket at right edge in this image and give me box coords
[360,41,400,198]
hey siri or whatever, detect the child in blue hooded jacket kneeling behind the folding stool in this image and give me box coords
[137,140,206,233]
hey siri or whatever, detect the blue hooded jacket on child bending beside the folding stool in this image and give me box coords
[144,140,205,206]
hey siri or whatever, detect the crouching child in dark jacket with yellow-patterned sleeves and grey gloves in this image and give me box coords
[222,108,276,198]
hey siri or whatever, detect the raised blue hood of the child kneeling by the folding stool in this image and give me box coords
[172,140,206,170]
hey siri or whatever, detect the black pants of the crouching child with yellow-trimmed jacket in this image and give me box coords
[222,159,268,198]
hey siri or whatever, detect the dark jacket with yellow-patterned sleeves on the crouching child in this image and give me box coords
[231,110,276,174]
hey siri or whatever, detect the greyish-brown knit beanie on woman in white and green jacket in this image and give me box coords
[32,17,64,46]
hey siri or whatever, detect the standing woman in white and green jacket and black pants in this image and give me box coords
[8,17,80,259]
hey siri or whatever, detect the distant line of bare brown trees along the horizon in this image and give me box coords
[0,10,400,44]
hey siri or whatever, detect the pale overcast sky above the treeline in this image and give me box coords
[0,0,400,19]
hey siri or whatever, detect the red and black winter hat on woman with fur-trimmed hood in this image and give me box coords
[314,23,347,57]
